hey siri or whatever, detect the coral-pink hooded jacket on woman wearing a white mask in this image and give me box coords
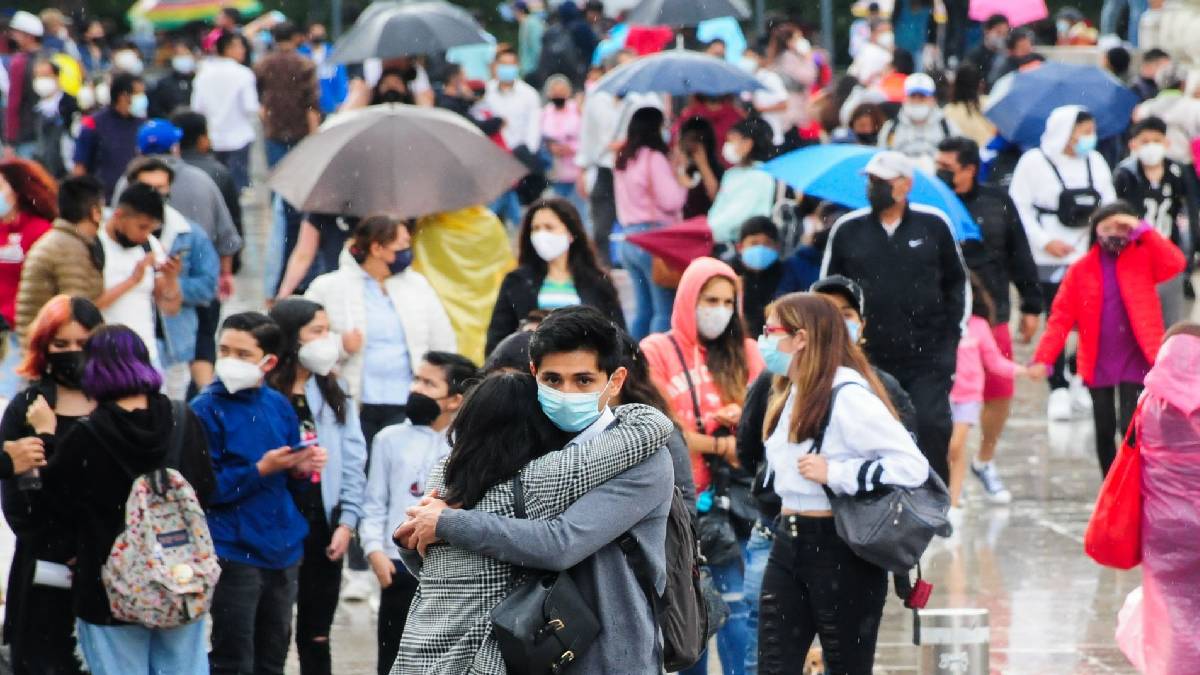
[642,258,763,494]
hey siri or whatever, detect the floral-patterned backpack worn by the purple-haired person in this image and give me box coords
[100,401,221,628]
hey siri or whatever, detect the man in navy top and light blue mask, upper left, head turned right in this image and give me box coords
[72,72,150,202]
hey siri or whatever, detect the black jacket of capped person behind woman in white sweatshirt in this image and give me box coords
[738,368,917,520]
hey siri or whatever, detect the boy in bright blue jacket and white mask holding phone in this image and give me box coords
[192,312,325,675]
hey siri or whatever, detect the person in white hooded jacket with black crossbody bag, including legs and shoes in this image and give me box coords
[1008,106,1116,420]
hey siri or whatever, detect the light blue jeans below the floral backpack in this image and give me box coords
[76,619,209,675]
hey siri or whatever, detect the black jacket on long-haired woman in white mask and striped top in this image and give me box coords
[485,265,625,354]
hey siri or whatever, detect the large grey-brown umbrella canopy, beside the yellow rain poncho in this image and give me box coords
[268,103,528,217]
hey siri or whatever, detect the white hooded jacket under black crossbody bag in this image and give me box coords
[1008,106,1117,270]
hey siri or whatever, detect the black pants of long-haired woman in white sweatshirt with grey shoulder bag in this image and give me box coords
[758,516,888,675]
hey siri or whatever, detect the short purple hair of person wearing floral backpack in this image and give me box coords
[83,324,162,401]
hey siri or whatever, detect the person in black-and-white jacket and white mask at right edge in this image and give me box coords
[1112,117,1195,327]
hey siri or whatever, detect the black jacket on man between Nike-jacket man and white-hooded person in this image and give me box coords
[960,185,1043,323]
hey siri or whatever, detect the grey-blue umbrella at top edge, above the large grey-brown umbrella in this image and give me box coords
[331,1,492,64]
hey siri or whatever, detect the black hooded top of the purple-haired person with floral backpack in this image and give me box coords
[44,394,216,626]
